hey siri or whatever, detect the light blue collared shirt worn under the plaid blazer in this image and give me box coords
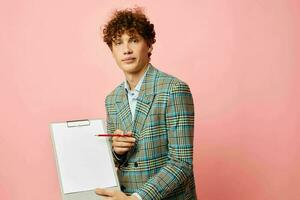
[124,64,149,121]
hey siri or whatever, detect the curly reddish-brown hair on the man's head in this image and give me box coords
[103,7,156,57]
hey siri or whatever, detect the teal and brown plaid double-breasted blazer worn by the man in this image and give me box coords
[105,65,196,200]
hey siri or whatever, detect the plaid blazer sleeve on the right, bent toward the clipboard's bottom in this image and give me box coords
[137,82,194,200]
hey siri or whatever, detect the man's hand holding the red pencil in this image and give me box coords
[112,129,135,155]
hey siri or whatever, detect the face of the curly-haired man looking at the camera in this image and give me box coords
[112,32,152,75]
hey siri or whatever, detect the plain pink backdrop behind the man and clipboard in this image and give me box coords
[0,0,300,200]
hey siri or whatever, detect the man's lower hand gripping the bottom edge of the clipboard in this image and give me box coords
[95,188,138,200]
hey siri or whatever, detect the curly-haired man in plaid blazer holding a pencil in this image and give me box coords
[96,8,196,200]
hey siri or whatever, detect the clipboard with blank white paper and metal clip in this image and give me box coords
[50,119,120,200]
